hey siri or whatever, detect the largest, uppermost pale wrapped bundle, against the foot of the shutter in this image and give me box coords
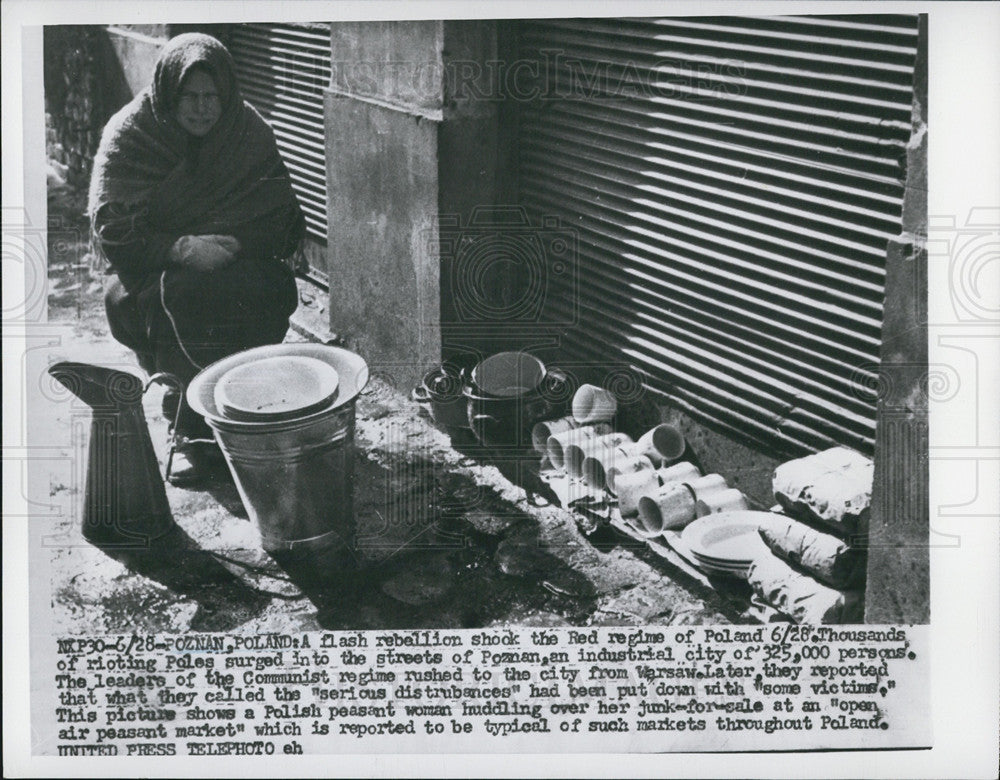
[772,447,875,535]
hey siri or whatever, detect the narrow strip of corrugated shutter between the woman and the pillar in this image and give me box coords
[230,24,331,276]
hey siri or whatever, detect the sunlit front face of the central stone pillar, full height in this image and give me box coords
[325,21,443,387]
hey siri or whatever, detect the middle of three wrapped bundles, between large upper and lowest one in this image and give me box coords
[760,515,865,588]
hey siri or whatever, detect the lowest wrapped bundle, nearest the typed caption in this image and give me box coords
[747,554,860,625]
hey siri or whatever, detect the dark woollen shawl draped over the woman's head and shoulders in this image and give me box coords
[88,33,297,241]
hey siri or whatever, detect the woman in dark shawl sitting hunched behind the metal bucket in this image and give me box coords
[89,33,305,483]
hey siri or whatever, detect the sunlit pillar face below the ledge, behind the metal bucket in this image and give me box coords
[326,94,441,386]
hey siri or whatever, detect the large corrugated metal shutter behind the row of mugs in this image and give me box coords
[518,16,917,454]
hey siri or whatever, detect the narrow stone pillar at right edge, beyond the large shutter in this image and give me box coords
[865,14,930,623]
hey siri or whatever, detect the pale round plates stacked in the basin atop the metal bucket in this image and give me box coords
[215,355,340,420]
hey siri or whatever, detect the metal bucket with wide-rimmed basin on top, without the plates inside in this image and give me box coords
[187,344,368,552]
